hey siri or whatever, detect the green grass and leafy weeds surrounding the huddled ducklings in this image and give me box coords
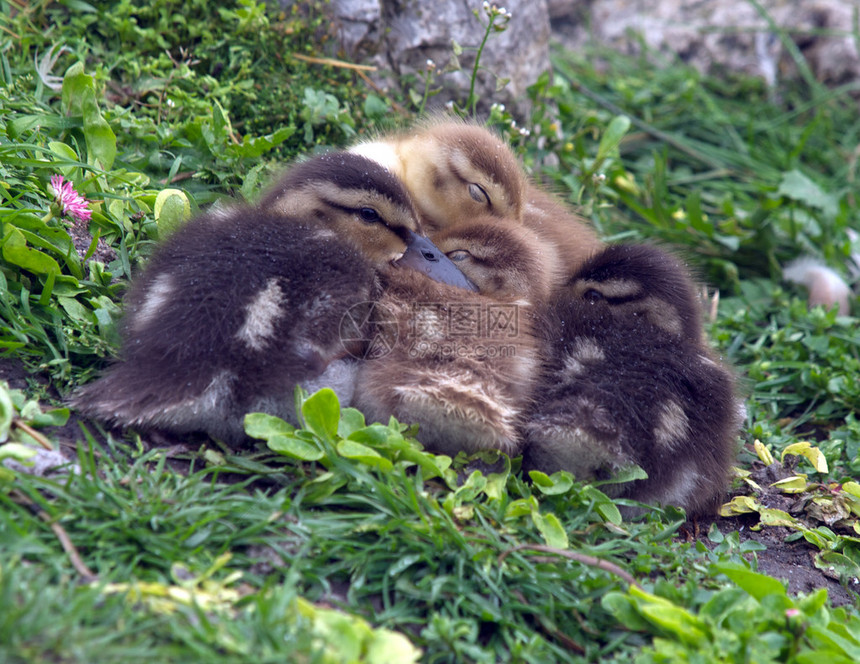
[0,0,860,662]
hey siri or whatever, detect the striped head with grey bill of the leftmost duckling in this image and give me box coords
[259,152,475,290]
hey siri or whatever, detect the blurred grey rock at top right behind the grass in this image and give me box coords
[550,0,860,85]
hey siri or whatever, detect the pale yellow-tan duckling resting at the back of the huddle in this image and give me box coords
[351,119,602,280]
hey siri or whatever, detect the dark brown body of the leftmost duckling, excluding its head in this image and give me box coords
[73,209,375,441]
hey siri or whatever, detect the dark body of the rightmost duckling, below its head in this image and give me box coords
[524,329,739,513]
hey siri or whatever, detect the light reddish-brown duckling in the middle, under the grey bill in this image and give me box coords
[355,218,550,456]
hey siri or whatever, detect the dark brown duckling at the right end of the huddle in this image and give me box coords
[523,245,741,516]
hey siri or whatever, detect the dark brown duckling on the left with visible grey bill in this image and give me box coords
[72,153,472,444]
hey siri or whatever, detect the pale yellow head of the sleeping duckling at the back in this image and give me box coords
[350,119,525,232]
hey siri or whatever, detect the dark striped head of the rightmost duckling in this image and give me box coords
[559,244,704,343]
